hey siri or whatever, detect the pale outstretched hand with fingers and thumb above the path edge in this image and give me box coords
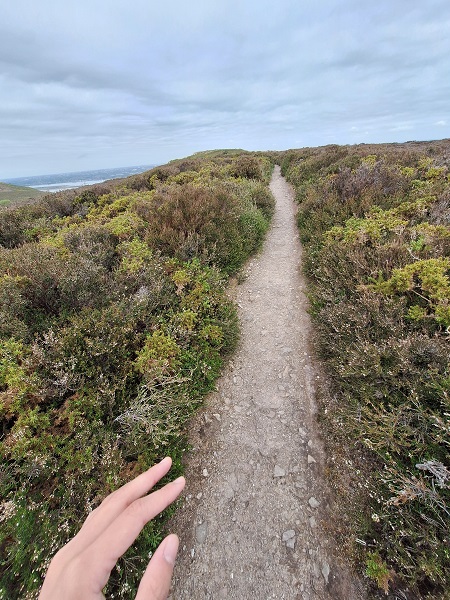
[39,457,185,600]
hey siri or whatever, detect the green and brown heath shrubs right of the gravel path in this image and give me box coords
[272,141,450,600]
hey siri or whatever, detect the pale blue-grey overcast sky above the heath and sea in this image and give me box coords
[0,0,450,180]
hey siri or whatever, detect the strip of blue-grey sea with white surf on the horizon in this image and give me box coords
[3,165,155,192]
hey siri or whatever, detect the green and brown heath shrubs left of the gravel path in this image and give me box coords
[0,152,273,599]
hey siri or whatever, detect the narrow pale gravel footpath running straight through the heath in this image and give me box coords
[170,167,362,600]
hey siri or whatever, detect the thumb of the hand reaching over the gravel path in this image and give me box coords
[136,534,180,600]
